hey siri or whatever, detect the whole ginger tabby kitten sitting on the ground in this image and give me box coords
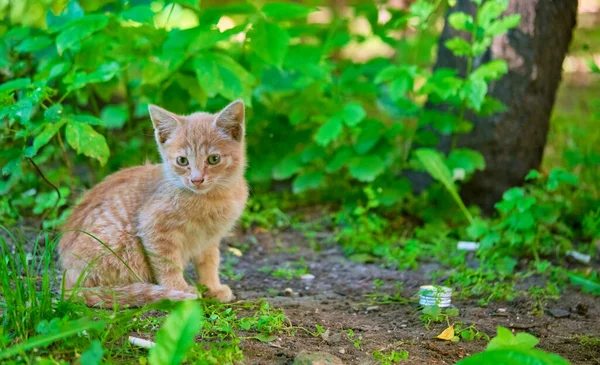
[59,100,248,307]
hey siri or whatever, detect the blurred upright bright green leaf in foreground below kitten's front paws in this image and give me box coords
[148,300,204,365]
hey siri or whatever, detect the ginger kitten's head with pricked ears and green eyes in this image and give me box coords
[148,100,245,193]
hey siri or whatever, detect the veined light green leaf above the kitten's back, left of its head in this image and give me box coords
[66,120,110,166]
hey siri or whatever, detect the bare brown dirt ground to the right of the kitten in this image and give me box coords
[229,232,600,364]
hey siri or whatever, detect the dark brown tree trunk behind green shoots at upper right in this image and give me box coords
[435,0,577,213]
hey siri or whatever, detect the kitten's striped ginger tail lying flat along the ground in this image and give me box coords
[73,283,198,308]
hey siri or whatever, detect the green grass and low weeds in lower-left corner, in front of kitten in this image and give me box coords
[0,228,289,364]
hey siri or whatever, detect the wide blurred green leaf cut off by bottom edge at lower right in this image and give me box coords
[456,349,569,365]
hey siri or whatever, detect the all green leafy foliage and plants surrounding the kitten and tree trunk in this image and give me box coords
[0,0,600,361]
